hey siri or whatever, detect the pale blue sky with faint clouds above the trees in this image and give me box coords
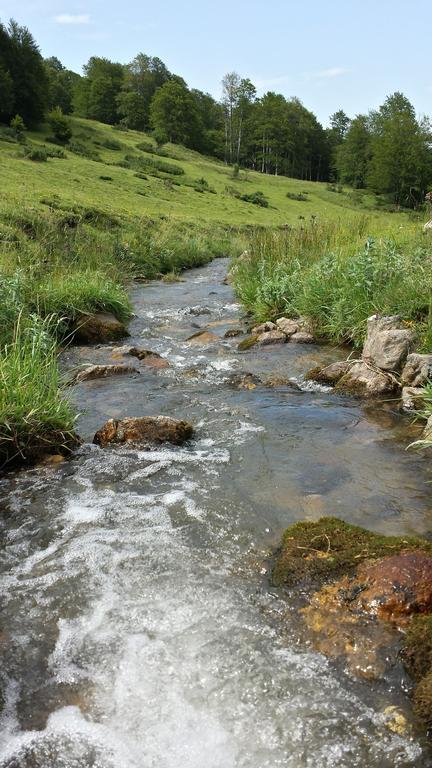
[0,0,432,124]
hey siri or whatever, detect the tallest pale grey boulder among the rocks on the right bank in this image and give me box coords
[362,315,416,372]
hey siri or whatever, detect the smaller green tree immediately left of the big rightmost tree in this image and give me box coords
[335,115,371,189]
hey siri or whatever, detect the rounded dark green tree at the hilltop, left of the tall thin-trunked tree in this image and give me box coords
[150,79,202,149]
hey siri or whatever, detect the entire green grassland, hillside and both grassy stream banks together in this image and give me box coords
[0,118,432,462]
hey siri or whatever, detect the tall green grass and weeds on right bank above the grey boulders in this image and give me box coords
[232,217,432,349]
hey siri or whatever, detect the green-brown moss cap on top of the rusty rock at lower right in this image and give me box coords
[272,517,432,586]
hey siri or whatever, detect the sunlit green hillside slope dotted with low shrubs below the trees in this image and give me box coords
[0,118,406,226]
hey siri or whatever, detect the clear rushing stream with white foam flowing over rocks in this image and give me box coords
[0,259,432,768]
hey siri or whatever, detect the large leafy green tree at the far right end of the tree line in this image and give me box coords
[367,93,431,206]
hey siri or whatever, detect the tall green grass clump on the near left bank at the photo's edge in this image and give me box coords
[0,316,74,463]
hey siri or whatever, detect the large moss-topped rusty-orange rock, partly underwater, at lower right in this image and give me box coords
[273,517,432,728]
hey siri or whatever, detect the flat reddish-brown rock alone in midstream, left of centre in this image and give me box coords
[93,416,194,448]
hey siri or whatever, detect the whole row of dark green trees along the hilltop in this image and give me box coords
[0,20,432,207]
